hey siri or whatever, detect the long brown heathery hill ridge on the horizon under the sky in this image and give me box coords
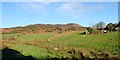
[2,23,84,34]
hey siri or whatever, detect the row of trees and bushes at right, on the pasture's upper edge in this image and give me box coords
[86,21,120,34]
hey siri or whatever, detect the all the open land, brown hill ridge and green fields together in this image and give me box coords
[1,23,120,60]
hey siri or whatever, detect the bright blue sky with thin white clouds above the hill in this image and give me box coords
[2,2,118,28]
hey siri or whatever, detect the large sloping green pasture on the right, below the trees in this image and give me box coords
[46,32,118,51]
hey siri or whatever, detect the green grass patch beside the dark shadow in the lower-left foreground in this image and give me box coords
[8,44,55,58]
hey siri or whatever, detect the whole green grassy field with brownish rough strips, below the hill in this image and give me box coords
[2,31,120,58]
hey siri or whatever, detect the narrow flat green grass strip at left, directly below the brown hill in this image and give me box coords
[2,33,55,41]
